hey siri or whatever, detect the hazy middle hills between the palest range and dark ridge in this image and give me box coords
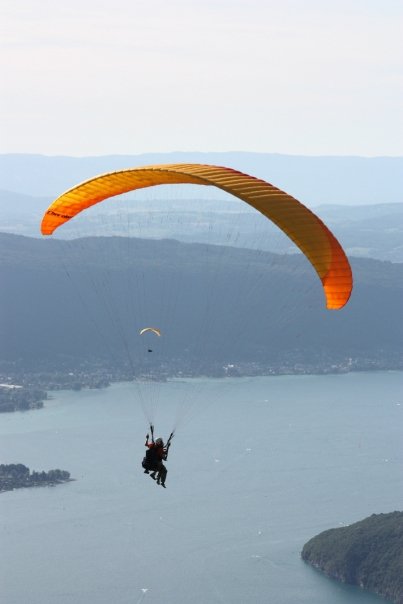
[0,187,403,262]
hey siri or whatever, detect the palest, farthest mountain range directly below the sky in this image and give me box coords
[0,152,403,207]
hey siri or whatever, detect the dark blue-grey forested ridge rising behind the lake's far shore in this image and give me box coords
[0,234,403,374]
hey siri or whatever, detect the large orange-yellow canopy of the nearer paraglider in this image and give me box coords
[41,164,353,309]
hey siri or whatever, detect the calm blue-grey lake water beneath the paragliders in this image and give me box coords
[0,372,403,604]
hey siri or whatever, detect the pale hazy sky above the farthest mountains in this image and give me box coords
[0,0,403,156]
